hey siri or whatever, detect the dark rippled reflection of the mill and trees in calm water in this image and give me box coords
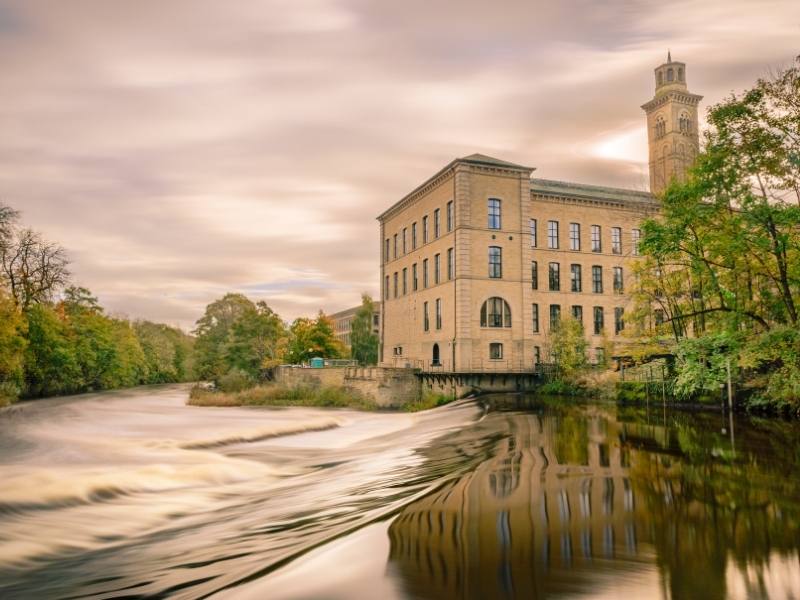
[389,396,800,600]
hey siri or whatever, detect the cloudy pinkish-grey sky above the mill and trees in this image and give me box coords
[0,0,800,329]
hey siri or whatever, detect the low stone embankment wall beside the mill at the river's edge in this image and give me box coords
[275,367,422,408]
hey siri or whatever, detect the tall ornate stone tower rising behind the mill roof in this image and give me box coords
[642,52,703,194]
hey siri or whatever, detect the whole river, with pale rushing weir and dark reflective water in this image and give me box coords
[0,386,800,600]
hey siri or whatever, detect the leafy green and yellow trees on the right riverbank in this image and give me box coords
[634,57,800,414]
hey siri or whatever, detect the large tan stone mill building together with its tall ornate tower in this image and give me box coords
[378,57,700,372]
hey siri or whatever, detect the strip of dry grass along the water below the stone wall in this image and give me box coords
[188,383,377,410]
